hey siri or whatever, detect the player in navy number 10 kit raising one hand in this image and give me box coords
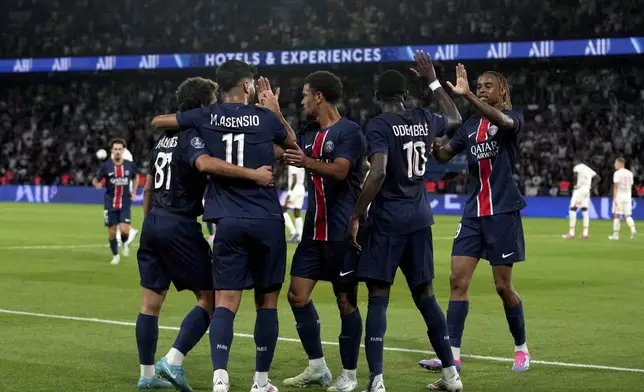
[349,51,463,392]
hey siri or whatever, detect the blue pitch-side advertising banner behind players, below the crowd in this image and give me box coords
[0,185,644,220]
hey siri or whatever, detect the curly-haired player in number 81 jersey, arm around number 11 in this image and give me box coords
[136,78,272,392]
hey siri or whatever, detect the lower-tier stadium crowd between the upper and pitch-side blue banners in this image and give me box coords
[0,62,644,195]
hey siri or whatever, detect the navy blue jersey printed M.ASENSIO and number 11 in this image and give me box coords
[177,103,286,221]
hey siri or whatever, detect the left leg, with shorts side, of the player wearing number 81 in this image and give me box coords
[135,220,172,389]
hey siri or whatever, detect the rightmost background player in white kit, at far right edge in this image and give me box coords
[608,158,637,240]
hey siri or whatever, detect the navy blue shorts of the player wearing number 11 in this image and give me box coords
[212,218,286,290]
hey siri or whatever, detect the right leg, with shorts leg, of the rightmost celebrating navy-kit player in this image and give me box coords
[483,211,530,372]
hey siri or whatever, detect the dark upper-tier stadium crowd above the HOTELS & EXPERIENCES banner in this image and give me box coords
[0,0,644,57]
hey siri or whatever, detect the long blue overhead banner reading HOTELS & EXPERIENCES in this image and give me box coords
[0,37,644,73]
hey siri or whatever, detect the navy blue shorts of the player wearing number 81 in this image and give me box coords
[137,208,213,291]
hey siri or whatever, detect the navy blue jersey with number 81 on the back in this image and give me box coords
[149,129,207,218]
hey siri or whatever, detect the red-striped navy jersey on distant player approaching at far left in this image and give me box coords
[96,159,137,211]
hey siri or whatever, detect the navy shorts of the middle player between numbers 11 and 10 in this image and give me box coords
[291,238,359,283]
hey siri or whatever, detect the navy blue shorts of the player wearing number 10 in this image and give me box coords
[358,226,434,288]
